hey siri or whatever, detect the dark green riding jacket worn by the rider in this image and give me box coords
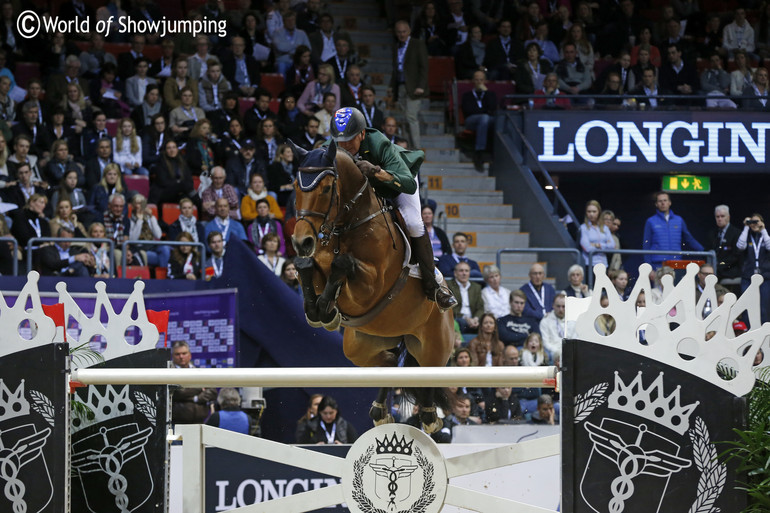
[324,128,425,199]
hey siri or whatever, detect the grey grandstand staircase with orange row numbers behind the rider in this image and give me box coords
[328,0,537,290]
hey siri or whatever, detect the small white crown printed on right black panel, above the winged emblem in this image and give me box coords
[608,371,700,435]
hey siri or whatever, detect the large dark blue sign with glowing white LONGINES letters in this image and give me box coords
[525,111,770,172]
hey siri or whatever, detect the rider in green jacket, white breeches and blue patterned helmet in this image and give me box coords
[331,107,457,310]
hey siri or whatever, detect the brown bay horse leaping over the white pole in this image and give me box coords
[291,141,454,433]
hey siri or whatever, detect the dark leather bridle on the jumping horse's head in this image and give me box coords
[297,148,376,249]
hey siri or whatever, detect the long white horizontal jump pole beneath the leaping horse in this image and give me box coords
[71,367,558,388]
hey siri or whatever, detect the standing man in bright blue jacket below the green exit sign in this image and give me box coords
[642,192,703,268]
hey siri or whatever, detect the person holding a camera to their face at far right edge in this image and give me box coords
[736,214,770,322]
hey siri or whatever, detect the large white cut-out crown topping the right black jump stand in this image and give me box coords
[567,264,770,396]
